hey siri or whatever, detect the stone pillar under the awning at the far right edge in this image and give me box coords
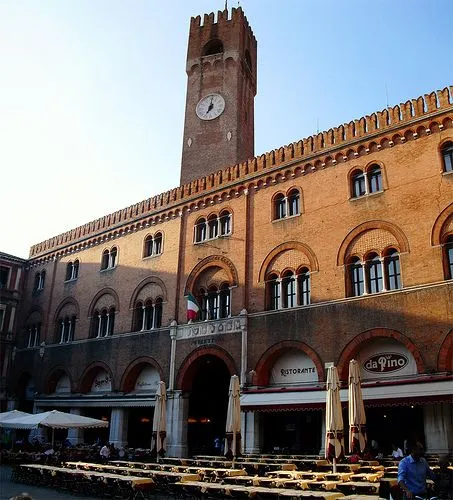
[423,403,453,454]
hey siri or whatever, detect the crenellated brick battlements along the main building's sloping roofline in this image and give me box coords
[29,86,453,264]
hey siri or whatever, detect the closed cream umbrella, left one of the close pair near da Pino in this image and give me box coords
[325,366,344,472]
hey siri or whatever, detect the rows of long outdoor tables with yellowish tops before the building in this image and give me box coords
[13,456,402,500]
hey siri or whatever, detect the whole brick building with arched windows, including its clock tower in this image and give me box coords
[4,8,453,456]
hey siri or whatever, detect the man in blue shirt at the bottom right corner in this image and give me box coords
[398,442,435,500]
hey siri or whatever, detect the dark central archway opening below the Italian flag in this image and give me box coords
[187,354,230,455]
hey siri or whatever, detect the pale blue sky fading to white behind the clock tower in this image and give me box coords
[0,0,453,258]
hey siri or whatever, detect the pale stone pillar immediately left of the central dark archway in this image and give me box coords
[167,391,189,457]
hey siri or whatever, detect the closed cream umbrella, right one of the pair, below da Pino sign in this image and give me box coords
[348,359,366,453]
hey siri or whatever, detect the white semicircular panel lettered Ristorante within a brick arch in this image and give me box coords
[269,350,318,386]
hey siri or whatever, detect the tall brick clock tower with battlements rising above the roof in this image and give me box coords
[180,7,256,185]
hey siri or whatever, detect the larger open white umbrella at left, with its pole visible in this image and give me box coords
[0,410,109,446]
